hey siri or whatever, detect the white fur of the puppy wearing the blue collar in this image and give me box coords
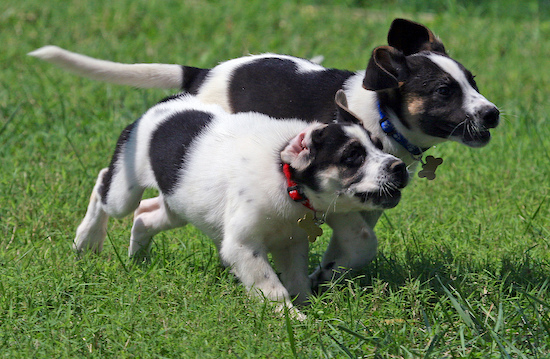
[31,48,500,292]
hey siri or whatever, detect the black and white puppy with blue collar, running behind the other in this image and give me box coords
[31,19,499,290]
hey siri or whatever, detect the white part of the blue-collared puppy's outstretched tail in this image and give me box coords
[29,46,186,89]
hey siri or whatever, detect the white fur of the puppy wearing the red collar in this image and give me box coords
[74,96,404,317]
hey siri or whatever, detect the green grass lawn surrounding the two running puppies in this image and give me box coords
[0,0,550,358]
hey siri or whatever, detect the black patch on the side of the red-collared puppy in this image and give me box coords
[149,111,212,195]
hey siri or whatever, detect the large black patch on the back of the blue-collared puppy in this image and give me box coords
[229,58,353,123]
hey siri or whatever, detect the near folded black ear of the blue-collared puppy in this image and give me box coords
[363,46,409,91]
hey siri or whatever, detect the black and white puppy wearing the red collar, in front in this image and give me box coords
[74,92,408,318]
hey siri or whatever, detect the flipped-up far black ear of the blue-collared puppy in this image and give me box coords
[388,19,446,56]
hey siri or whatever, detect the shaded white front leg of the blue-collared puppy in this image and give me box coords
[310,211,382,289]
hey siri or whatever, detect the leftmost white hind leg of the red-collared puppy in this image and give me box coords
[73,168,109,253]
